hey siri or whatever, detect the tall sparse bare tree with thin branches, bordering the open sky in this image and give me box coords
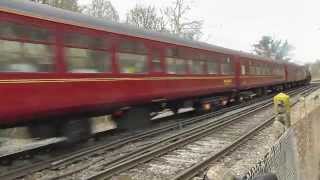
[163,0,203,40]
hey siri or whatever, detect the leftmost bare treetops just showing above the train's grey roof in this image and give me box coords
[30,0,81,12]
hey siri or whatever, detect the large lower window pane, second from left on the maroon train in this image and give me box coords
[65,48,111,73]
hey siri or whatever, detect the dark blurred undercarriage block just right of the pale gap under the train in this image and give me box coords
[115,107,151,130]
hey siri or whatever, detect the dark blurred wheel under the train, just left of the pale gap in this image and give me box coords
[60,119,91,145]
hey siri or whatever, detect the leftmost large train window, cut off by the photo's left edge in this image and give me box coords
[0,22,54,72]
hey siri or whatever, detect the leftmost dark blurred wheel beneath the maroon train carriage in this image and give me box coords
[28,122,57,139]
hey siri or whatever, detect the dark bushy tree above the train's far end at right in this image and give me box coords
[253,36,293,61]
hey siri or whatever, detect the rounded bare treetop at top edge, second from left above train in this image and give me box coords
[84,0,119,22]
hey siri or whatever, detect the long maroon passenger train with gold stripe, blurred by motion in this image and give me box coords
[0,0,306,142]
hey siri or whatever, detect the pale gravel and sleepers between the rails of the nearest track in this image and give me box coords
[109,105,273,180]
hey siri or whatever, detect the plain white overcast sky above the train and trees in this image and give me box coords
[79,0,320,63]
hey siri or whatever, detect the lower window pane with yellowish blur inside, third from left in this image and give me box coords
[118,53,148,74]
